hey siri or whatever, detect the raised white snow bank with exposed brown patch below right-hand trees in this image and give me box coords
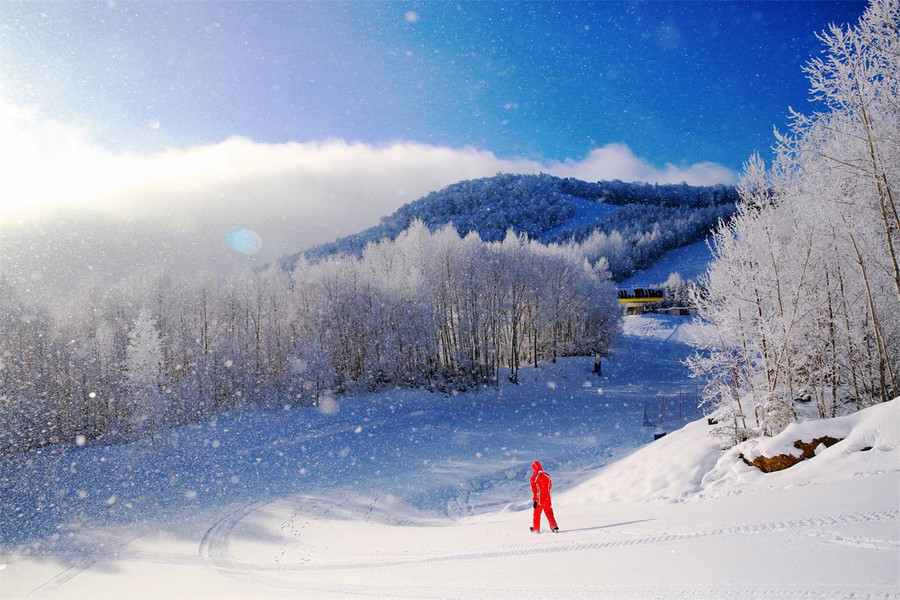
[561,398,900,504]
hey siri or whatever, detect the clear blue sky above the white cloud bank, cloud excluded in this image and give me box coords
[0,0,864,170]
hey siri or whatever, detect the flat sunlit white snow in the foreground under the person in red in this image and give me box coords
[19,473,900,600]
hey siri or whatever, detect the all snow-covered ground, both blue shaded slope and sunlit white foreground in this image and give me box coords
[0,316,900,598]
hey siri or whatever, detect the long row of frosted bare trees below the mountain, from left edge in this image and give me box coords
[0,222,619,452]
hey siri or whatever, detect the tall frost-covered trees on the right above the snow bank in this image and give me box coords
[693,0,900,441]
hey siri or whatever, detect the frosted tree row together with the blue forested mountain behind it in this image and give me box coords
[0,169,736,451]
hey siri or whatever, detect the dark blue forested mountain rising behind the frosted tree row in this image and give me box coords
[281,174,738,281]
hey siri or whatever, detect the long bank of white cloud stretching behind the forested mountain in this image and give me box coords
[0,100,736,292]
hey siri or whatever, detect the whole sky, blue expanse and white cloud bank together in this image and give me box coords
[0,0,864,285]
